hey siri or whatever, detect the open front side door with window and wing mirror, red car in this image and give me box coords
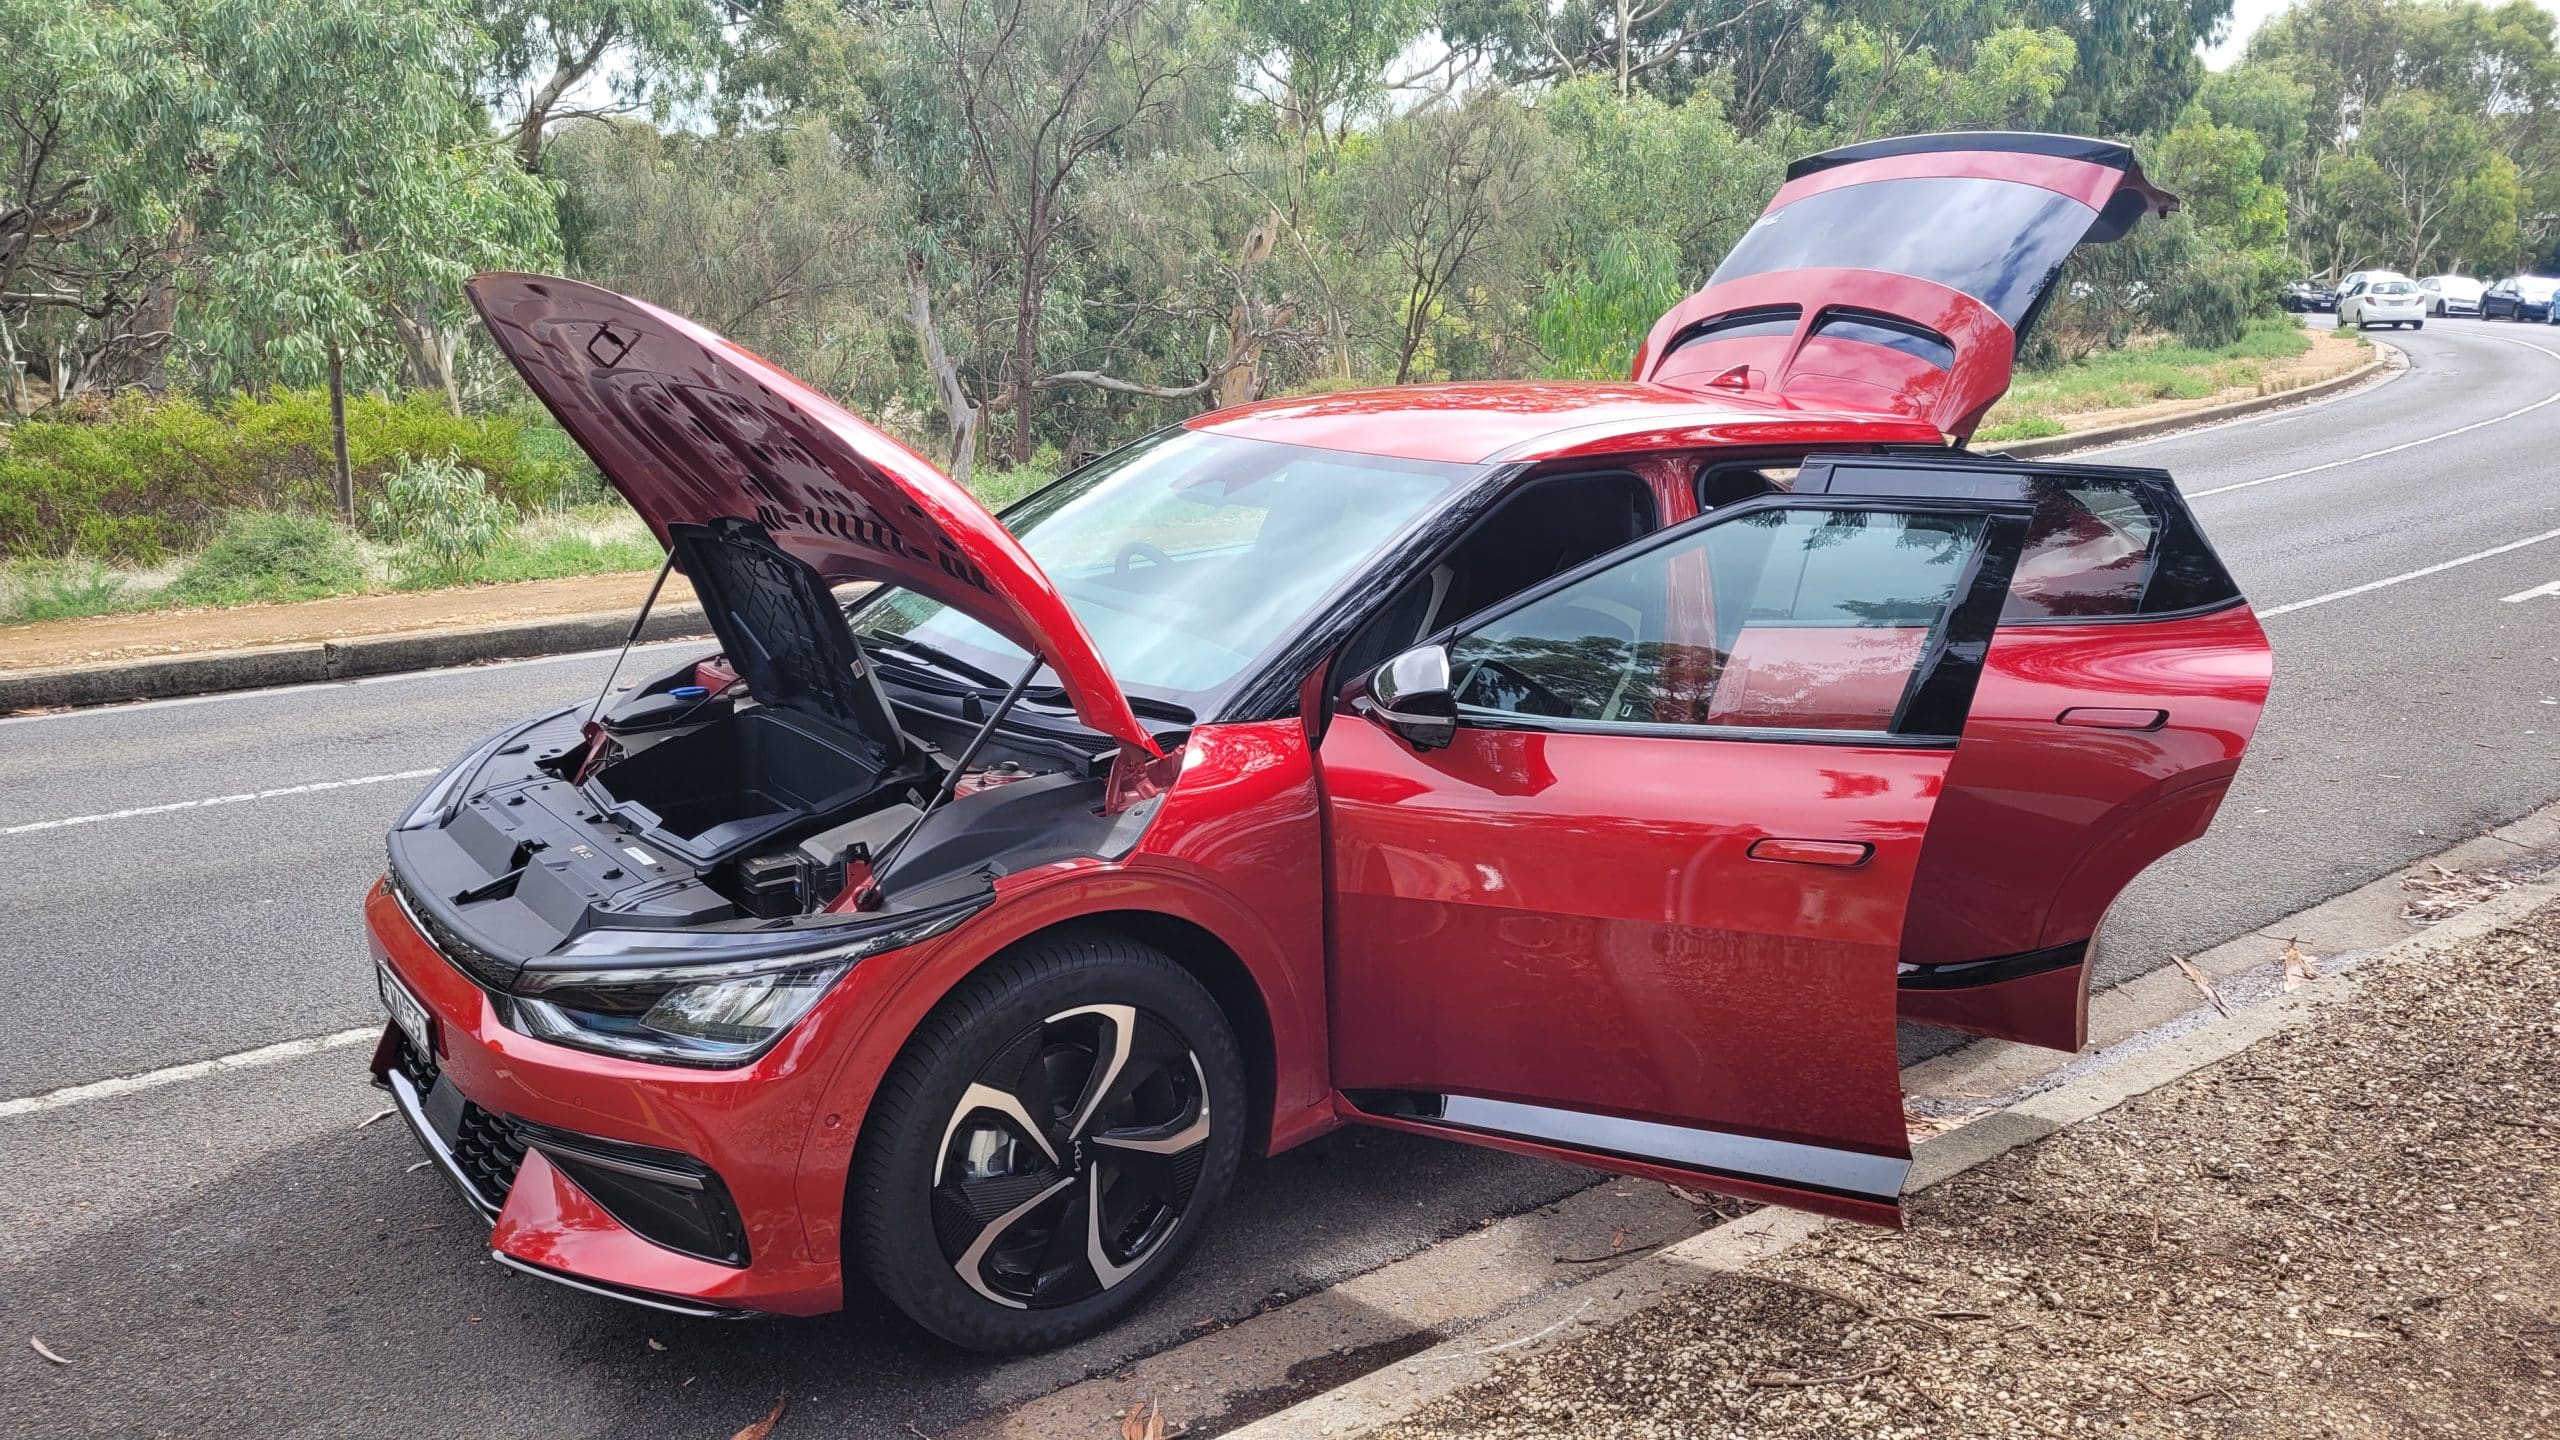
[1318,495,2033,1222]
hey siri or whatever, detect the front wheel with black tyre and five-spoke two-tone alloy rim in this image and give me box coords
[845,928,1249,1353]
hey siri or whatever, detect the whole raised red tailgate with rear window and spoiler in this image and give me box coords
[1633,131,2179,441]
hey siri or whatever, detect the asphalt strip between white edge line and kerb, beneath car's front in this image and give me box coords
[0,1096,1597,1440]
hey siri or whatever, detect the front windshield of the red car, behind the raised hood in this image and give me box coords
[852,430,1485,712]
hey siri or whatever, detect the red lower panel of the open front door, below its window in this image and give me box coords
[1324,715,1948,1194]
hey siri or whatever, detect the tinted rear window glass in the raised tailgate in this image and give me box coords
[1708,177,2097,328]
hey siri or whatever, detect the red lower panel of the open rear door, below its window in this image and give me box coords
[1902,605,2273,1048]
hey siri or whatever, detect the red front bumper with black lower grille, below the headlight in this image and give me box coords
[366,887,845,1317]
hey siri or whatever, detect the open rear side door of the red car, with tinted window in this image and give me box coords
[1795,456,2273,1051]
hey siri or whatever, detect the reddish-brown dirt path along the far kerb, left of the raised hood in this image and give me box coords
[0,571,694,669]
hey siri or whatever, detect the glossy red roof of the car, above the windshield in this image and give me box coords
[1188,379,1946,464]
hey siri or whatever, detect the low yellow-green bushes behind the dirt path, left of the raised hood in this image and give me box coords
[0,389,576,561]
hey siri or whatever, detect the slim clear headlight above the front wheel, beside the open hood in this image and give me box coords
[499,897,986,1066]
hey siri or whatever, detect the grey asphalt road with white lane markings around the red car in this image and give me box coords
[0,323,2560,1437]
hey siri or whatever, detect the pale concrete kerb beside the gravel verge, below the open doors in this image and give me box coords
[1226,835,2560,1440]
